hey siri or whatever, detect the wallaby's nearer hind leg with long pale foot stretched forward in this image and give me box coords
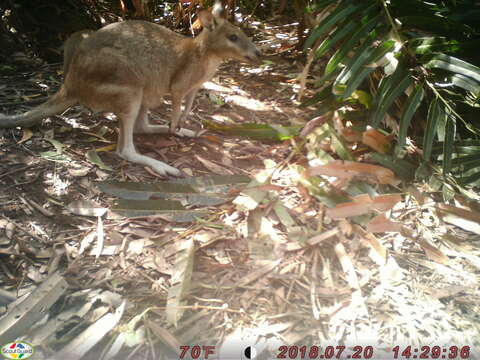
[117,96,181,176]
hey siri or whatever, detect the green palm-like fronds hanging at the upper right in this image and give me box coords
[304,0,480,186]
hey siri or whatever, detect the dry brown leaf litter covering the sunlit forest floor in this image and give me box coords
[0,19,480,359]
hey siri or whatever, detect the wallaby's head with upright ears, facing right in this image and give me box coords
[198,2,261,63]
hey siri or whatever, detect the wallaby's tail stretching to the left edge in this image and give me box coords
[0,86,76,128]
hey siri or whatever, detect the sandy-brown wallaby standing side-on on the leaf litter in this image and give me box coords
[0,1,261,176]
